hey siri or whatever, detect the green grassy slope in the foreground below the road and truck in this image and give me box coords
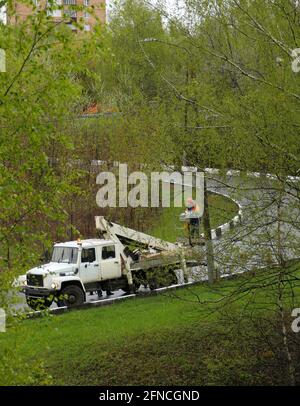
[0,262,300,385]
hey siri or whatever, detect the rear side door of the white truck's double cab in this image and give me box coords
[100,245,121,280]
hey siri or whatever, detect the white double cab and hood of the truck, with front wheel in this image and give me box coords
[20,239,128,310]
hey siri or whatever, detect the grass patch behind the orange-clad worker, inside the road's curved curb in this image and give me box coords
[147,193,239,242]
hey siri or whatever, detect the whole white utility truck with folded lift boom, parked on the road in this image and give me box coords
[20,216,196,310]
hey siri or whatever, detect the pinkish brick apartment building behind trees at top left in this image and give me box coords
[7,0,106,32]
